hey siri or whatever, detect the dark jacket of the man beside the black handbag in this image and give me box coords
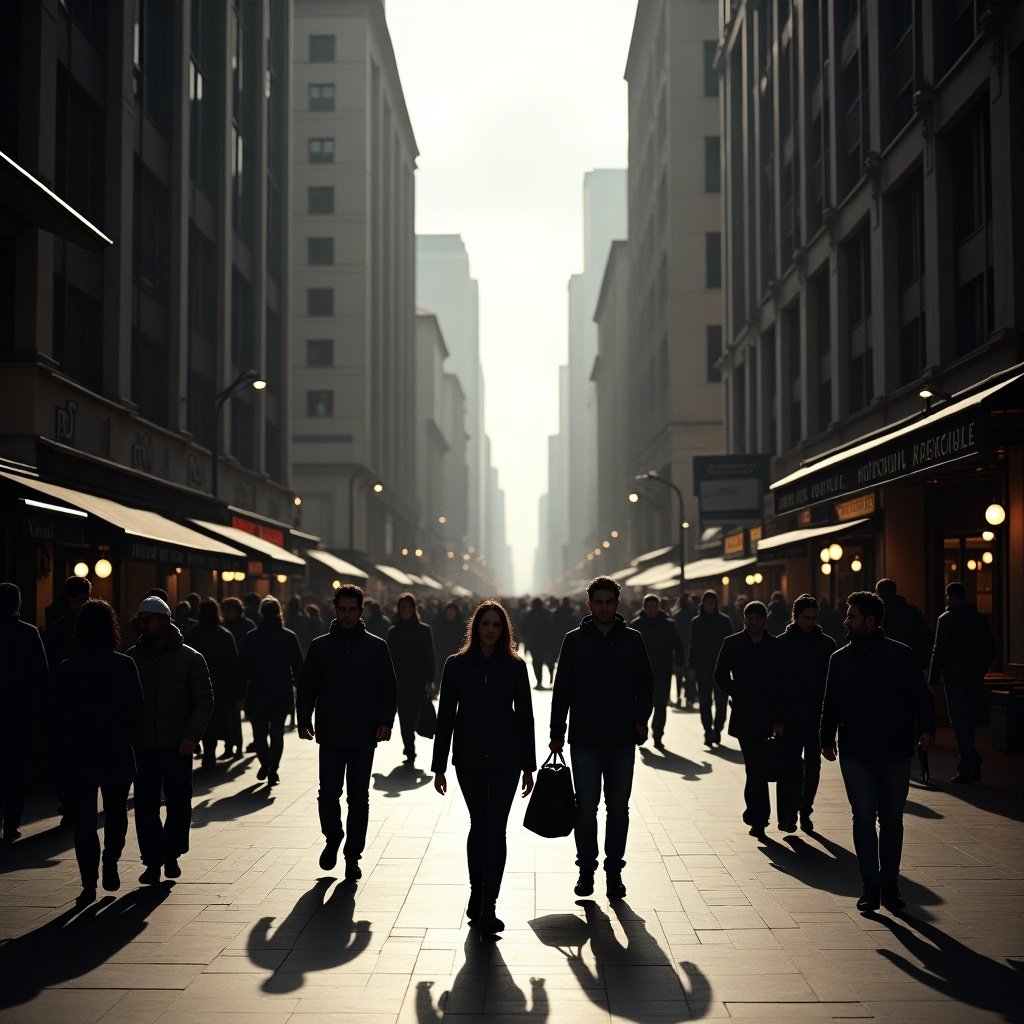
[551,614,654,748]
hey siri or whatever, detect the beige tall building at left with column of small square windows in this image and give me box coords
[291,0,419,559]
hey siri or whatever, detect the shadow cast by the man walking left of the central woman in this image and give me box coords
[246,878,373,993]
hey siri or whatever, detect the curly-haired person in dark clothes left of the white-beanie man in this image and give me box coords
[55,600,142,905]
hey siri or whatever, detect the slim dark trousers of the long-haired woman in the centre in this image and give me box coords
[455,766,519,906]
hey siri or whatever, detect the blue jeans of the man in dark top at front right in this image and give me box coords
[839,756,910,886]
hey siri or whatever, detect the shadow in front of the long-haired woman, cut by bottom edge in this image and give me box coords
[416,933,548,1024]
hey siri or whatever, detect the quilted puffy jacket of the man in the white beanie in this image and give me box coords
[125,623,213,746]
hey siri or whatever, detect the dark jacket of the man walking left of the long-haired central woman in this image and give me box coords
[298,620,398,749]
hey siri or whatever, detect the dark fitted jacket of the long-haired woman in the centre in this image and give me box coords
[431,652,537,772]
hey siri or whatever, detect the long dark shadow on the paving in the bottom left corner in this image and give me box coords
[0,885,174,1009]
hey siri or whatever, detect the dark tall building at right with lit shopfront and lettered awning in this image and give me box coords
[719,0,1024,674]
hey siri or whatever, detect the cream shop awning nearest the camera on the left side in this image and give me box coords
[0,473,246,568]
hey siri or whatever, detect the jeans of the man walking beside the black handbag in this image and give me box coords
[569,743,636,872]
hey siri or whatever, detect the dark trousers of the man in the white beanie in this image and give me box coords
[134,746,191,867]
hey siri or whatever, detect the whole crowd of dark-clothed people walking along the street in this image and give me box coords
[0,577,994,932]
